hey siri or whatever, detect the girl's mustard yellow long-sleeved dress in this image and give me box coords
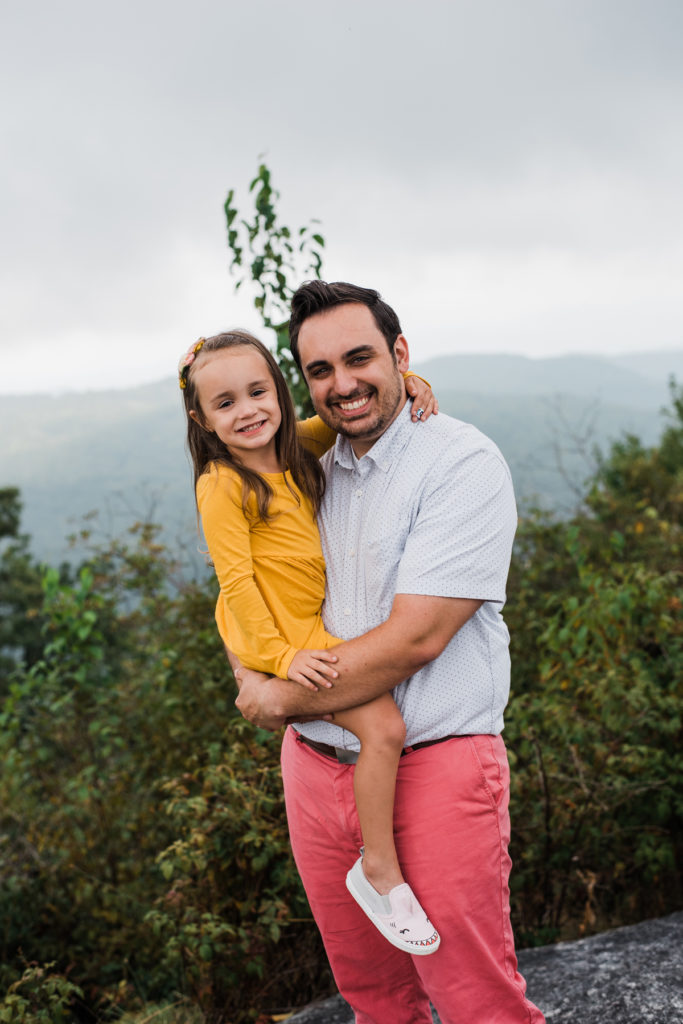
[197,417,339,679]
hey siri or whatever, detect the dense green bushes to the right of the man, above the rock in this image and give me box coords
[506,387,683,941]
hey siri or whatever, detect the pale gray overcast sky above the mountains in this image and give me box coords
[0,0,683,393]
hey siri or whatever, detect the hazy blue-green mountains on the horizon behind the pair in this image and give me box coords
[0,350,683,562]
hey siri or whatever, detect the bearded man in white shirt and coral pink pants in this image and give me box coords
[238,282,544,1024]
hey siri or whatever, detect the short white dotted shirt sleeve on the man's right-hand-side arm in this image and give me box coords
[396,450,517,604]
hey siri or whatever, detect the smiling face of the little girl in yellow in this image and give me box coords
[189,345,283,473]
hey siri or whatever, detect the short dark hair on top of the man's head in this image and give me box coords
[290,281,402,370]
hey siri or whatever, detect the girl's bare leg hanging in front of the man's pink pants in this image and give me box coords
[334,693,405,895]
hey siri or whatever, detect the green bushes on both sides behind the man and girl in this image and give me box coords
[0,381,683,1024]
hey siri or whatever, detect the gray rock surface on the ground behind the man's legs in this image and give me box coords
[288,912,683,1024]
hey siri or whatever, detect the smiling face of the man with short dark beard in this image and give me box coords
[299,303,409,456]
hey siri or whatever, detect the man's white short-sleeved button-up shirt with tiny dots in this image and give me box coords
[297,402,517,750]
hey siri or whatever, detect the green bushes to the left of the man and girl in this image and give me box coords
[0,526,331,1022]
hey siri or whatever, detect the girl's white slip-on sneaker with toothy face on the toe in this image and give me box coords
[346,857,441,956]
